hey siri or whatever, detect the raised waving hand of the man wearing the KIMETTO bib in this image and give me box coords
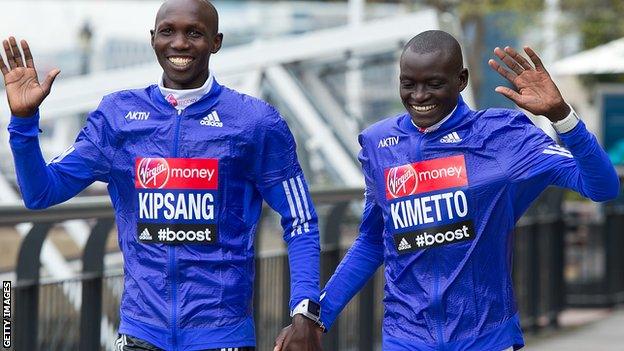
[488,46,570,122]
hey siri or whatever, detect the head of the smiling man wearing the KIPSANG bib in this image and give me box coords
[150,0,223,89]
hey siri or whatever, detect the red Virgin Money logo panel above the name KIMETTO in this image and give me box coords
[385,155,468,200]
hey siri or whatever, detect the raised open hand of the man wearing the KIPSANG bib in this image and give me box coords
[0,37,61,117]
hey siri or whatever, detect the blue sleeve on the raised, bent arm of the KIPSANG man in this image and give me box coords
[8,97,113,209]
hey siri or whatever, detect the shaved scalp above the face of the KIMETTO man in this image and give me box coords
[401,30,464,70]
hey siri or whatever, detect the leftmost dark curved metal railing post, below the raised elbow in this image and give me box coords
[14,223,52,351]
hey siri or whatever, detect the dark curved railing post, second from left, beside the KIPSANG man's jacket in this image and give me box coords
[79,218,114,350]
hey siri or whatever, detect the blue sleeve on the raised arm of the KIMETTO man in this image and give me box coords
[499,114,619,219]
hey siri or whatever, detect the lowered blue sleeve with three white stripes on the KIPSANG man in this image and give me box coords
[254,109,320,310]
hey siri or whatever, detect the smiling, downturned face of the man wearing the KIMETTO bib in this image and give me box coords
[399,49,468,128]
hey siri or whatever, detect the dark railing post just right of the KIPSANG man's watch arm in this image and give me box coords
[321,202,349,350]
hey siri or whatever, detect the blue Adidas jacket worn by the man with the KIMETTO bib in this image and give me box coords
[321,98,619,351]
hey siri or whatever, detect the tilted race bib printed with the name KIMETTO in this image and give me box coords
[384,155,475,254]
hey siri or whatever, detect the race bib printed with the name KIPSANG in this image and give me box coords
[135,157,219,244]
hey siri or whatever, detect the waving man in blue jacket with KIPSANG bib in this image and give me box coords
[0,0,320,351]
